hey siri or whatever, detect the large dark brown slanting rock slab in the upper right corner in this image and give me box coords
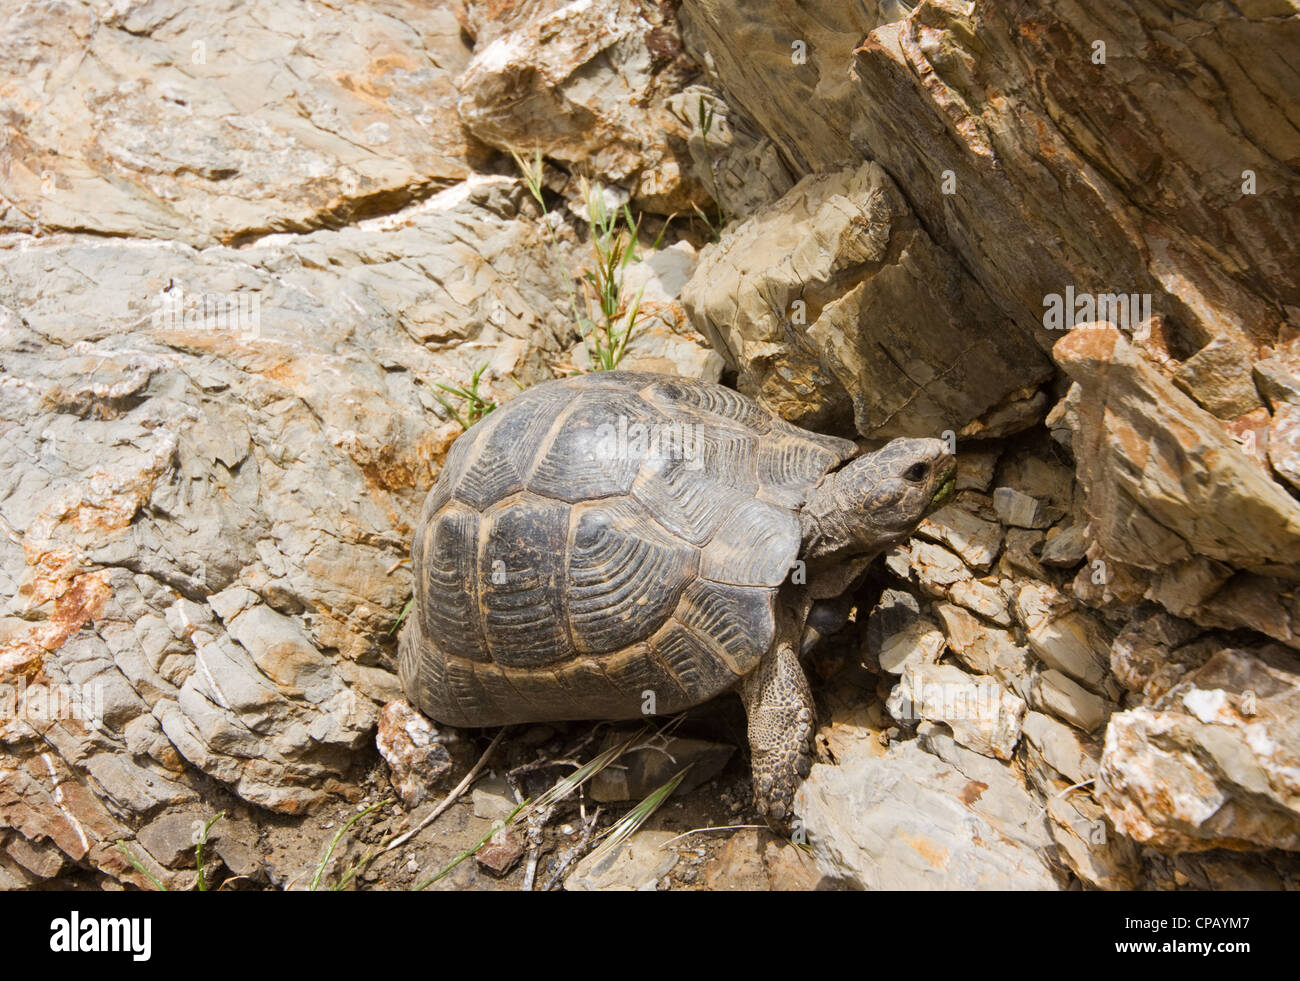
[680,0,1300,376]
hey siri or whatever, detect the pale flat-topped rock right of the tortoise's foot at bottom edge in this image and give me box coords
[796,742,1058,890]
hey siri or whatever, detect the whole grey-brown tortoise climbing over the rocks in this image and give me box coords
[399,370,956,830]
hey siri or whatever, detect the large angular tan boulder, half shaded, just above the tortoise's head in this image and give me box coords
[683,162,1045,437]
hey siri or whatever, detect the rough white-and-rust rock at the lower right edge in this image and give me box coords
[1097,647,1300,851]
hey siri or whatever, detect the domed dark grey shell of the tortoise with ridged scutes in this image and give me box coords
[400,372,857,726]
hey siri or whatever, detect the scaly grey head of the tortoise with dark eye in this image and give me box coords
[835,439,957,551]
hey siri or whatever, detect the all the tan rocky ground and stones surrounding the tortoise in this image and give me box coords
[0,0,1300,889]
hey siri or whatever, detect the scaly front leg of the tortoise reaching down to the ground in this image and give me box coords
[741,639,814,834]
